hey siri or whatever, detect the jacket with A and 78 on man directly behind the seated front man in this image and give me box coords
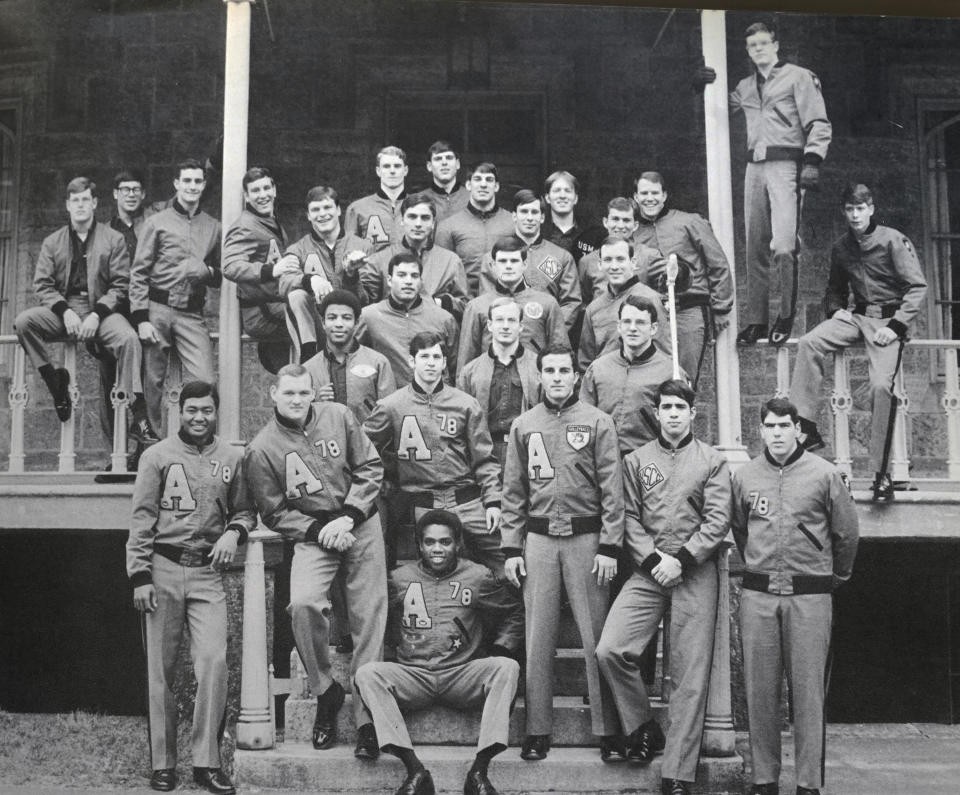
[363,381,500,508]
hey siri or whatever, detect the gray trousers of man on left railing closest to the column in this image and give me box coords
[143,301,214,431]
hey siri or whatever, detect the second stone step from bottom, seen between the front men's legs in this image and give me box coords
[284,696,666,746]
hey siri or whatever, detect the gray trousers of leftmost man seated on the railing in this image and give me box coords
[14,296,143,400]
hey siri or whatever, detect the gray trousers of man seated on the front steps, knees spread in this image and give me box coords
[356,657,520,751]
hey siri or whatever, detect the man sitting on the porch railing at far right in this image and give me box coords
[790,183,927,500]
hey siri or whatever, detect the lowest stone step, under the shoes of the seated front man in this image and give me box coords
[234,743,744,795]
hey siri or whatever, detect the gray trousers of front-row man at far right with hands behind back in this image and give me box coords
[740,589,833,789]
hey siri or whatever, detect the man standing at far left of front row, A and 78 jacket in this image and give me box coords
[127,381,256,795]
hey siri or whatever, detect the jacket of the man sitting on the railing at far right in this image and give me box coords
[824,223,927,337]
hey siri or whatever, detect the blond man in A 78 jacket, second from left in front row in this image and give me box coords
[244,364,387,756]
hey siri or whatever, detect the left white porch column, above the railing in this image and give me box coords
[217,0,252,440]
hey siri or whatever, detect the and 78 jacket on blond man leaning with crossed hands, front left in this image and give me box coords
[244,402,383,542]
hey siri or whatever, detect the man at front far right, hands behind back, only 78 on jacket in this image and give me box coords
[731,398,859,795]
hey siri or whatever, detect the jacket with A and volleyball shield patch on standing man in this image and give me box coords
[500,396,623,558]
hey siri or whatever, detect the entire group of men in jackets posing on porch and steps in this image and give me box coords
[16,18,926,795]
